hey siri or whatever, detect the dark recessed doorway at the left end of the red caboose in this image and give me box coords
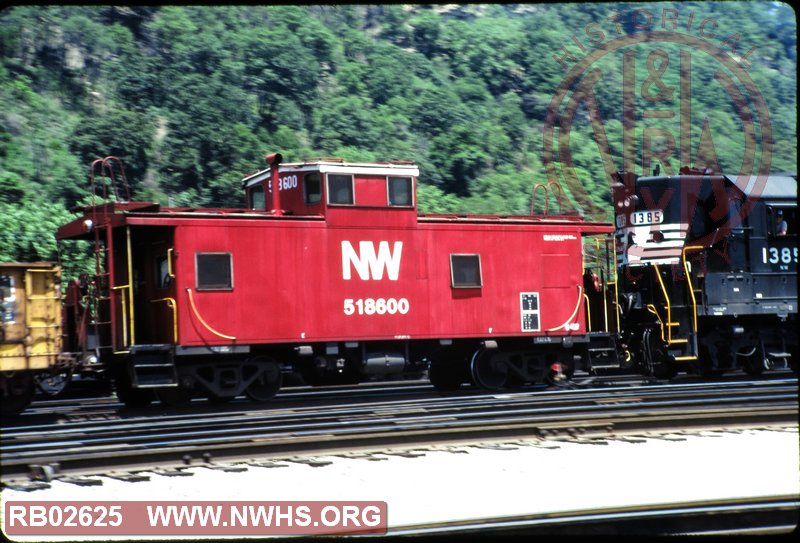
[133,226,177,345]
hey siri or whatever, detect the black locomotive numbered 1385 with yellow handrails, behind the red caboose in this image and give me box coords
[613,169,798,377]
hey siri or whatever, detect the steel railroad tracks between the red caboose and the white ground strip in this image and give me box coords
[0,377,798,483]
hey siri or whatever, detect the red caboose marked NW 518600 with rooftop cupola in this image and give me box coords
[58,154,613,405]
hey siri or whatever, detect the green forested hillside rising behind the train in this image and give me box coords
[0,2,797,270]
